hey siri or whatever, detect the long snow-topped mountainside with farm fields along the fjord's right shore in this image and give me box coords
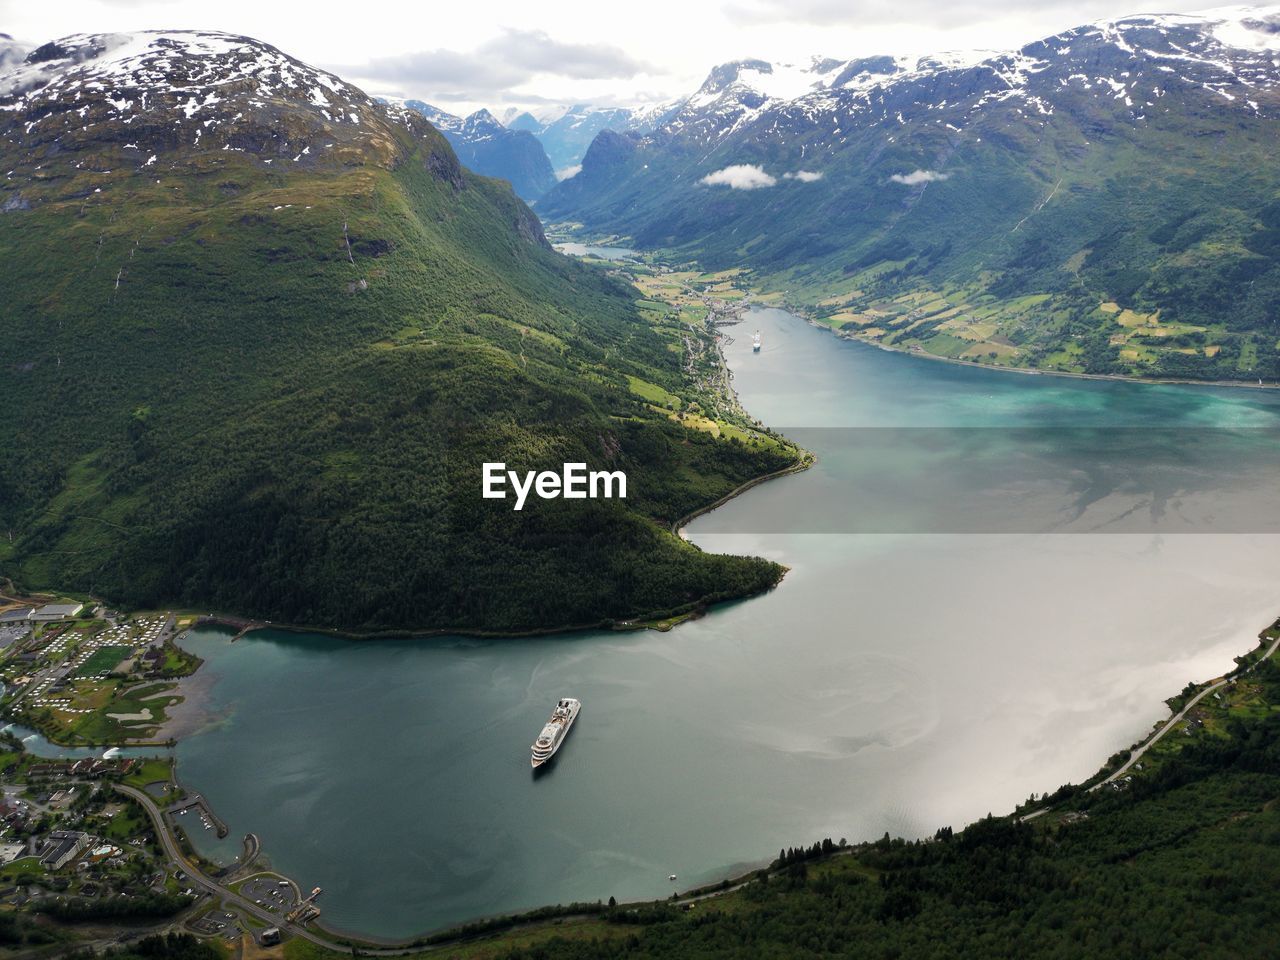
[539,8,1280,379]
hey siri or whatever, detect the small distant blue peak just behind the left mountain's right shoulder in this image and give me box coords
[404,100,556,200]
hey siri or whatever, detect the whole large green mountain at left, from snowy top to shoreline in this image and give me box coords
[0,32,792,630]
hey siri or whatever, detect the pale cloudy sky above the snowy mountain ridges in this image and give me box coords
[0,0,1206,113]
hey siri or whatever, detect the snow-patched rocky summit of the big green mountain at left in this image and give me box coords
[0,31,440,165]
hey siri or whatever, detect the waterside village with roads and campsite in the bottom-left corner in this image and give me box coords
[0,600,320,956]
